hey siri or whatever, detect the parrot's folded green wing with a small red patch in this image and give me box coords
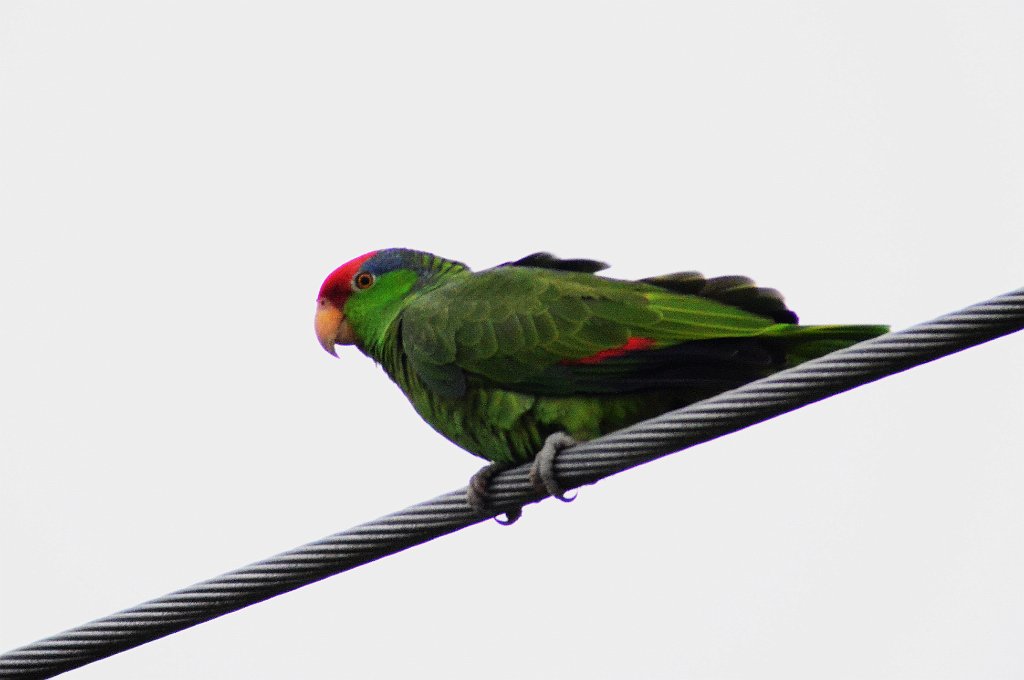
[400,266,881,397]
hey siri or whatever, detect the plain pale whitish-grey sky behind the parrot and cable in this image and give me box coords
[0,0,1024,679]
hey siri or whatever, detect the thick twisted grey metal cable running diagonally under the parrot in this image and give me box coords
[0,288,1024,678]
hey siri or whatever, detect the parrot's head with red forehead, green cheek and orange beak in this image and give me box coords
[313,248,464,356]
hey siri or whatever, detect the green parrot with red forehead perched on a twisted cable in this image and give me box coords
[314,248,889,523]
